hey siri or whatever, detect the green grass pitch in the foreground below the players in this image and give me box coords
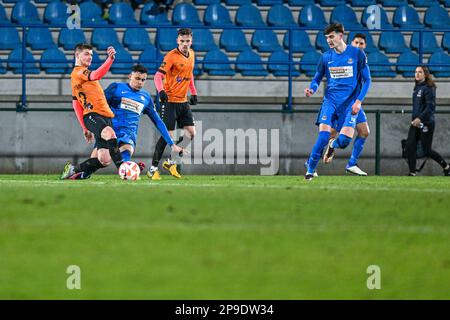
[0,175,450,299]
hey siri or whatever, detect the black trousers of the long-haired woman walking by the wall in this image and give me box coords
[406,122,447,172]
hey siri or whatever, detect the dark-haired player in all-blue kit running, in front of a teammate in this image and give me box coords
[305,23,371,180]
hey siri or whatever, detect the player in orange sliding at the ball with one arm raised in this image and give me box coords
[61,44,122,179]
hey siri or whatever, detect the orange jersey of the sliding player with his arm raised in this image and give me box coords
[70,66,114,118]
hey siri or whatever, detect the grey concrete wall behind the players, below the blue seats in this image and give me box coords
[0,104,450,175]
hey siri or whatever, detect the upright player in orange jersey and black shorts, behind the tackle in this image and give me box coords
[147,28,197,180]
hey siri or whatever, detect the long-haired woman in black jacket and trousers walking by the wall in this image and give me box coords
[406,66,450,176]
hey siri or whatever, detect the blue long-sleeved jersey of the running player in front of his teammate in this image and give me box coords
[310,45,370,110]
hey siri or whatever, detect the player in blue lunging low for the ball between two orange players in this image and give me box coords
[70,65,184,179]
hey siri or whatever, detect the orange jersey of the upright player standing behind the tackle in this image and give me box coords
[158,48,195,103]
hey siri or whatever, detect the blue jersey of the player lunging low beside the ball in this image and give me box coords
[105,82,173,145]
